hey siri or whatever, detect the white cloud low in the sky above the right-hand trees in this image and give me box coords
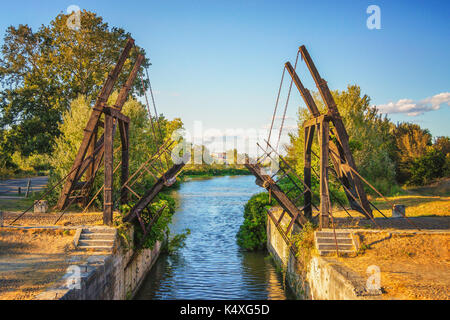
[377,92,450,117]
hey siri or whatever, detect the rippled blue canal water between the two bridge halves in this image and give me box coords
[136,176,294,300]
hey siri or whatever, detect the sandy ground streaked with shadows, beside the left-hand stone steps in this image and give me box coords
[0,228,93,300]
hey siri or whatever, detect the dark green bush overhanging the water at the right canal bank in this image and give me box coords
[237,193,276,251]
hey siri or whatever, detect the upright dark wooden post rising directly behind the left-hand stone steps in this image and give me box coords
[103,114,114,225]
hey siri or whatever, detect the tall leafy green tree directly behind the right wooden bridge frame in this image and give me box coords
[286,85,395,193]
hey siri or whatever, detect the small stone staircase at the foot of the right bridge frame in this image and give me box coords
[314,229,358,256]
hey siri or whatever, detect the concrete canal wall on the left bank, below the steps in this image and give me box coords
[36,226,162,300]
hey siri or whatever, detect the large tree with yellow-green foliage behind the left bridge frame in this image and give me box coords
[0,11,149,159]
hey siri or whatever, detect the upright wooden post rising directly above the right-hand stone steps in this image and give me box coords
[319,121,330,229]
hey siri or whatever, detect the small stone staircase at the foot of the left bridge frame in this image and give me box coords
[75,227,116,252]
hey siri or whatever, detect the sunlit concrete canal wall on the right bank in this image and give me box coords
[267,212,381,300]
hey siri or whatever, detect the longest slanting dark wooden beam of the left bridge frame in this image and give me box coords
[56,39,134,210]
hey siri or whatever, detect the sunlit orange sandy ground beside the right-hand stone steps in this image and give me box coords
[339,232,450,300]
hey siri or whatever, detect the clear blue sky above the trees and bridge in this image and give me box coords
[0,0,450,152]
